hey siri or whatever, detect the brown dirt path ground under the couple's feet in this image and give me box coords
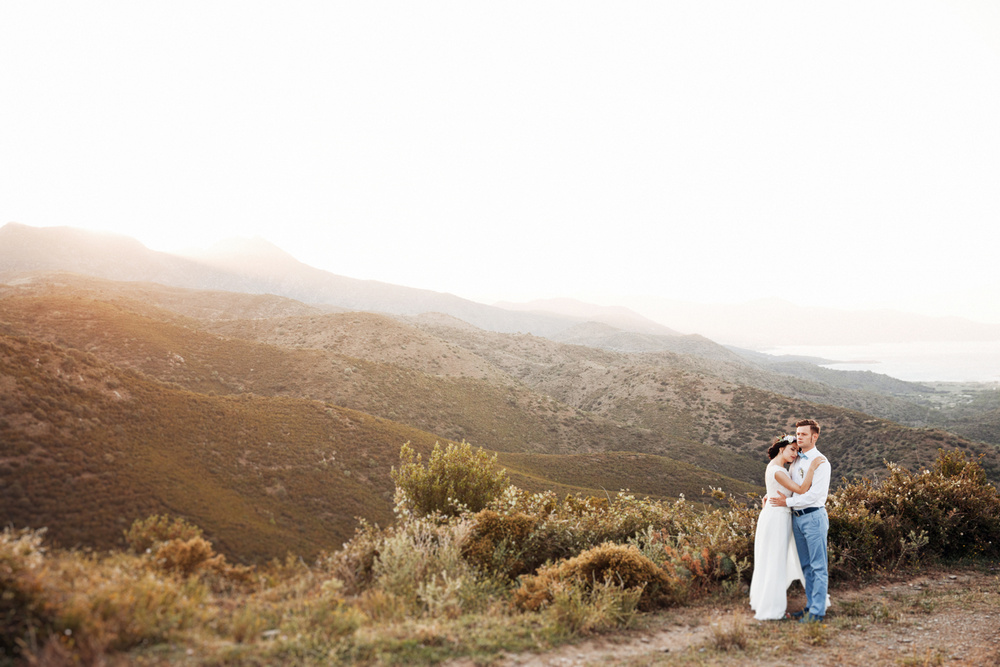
[468,568,1000,667]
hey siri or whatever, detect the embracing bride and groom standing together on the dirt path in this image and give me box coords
[750,419,830,622]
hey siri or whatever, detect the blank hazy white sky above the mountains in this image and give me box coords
[0,0,1000,322]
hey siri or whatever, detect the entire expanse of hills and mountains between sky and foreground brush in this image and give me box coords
[0,225,1000,561]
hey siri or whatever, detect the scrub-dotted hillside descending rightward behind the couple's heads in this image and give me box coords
[413,318,1000,481]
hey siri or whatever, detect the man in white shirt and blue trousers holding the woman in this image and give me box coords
[771,419,831,623]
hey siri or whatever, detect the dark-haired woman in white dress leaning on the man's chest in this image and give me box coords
[750,435,826,621]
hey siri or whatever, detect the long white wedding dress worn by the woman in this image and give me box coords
[750,464,805,621]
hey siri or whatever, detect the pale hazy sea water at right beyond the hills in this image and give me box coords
[761,341,1000,382]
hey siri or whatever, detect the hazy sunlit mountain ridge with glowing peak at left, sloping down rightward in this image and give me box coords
[0,223,671,336]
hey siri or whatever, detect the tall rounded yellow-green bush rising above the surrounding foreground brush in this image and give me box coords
[392,441,510,516]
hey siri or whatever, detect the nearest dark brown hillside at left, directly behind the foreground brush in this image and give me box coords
[0,335,414,559]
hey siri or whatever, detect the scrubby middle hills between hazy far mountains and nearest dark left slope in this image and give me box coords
[4,272,1000,484]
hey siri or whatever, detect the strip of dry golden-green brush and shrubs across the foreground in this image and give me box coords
[0,445,1000,665]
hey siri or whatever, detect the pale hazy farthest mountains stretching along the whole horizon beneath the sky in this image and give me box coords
[0,223,1000,350]
